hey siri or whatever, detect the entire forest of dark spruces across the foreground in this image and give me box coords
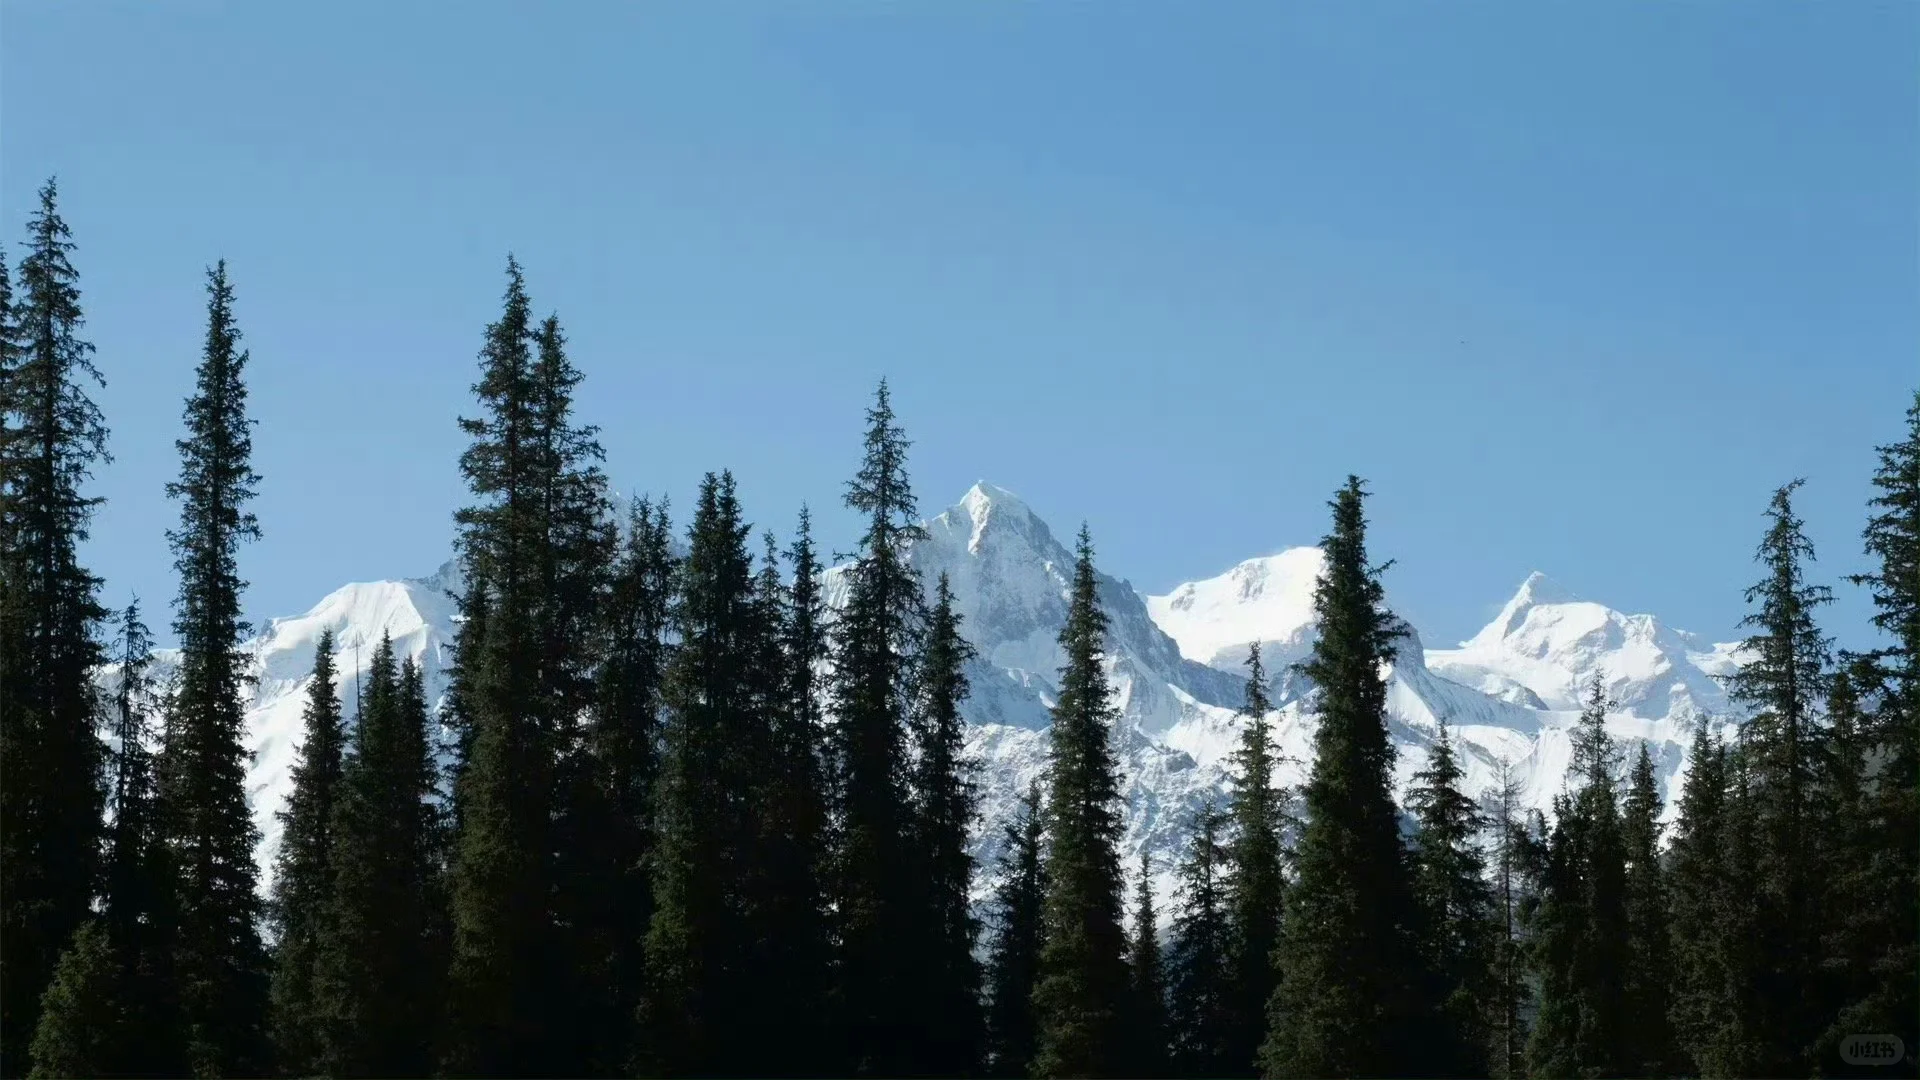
[0,181,1920,1078]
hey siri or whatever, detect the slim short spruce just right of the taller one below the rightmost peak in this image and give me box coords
[1620,742,1676,1076]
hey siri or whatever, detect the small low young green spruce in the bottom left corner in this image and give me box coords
[31,919,125,1080]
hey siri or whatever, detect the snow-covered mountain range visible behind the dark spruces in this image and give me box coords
[172,484,1734,894]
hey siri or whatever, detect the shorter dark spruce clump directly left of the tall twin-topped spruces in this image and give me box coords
[315,636,444,1076]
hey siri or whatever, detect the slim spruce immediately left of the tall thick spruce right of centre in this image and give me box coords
[1227,642,1286,1076]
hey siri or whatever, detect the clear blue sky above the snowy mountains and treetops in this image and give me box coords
[0,0,1920,642]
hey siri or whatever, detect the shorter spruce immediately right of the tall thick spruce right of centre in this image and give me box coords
[1407,721,1496,1076]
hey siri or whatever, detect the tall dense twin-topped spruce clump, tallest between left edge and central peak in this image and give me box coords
[445,259,612,1074]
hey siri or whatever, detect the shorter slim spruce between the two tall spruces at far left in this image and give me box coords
[102,601,180,1076]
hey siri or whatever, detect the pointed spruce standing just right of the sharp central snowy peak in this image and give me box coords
[1033,527,1127,1076]
